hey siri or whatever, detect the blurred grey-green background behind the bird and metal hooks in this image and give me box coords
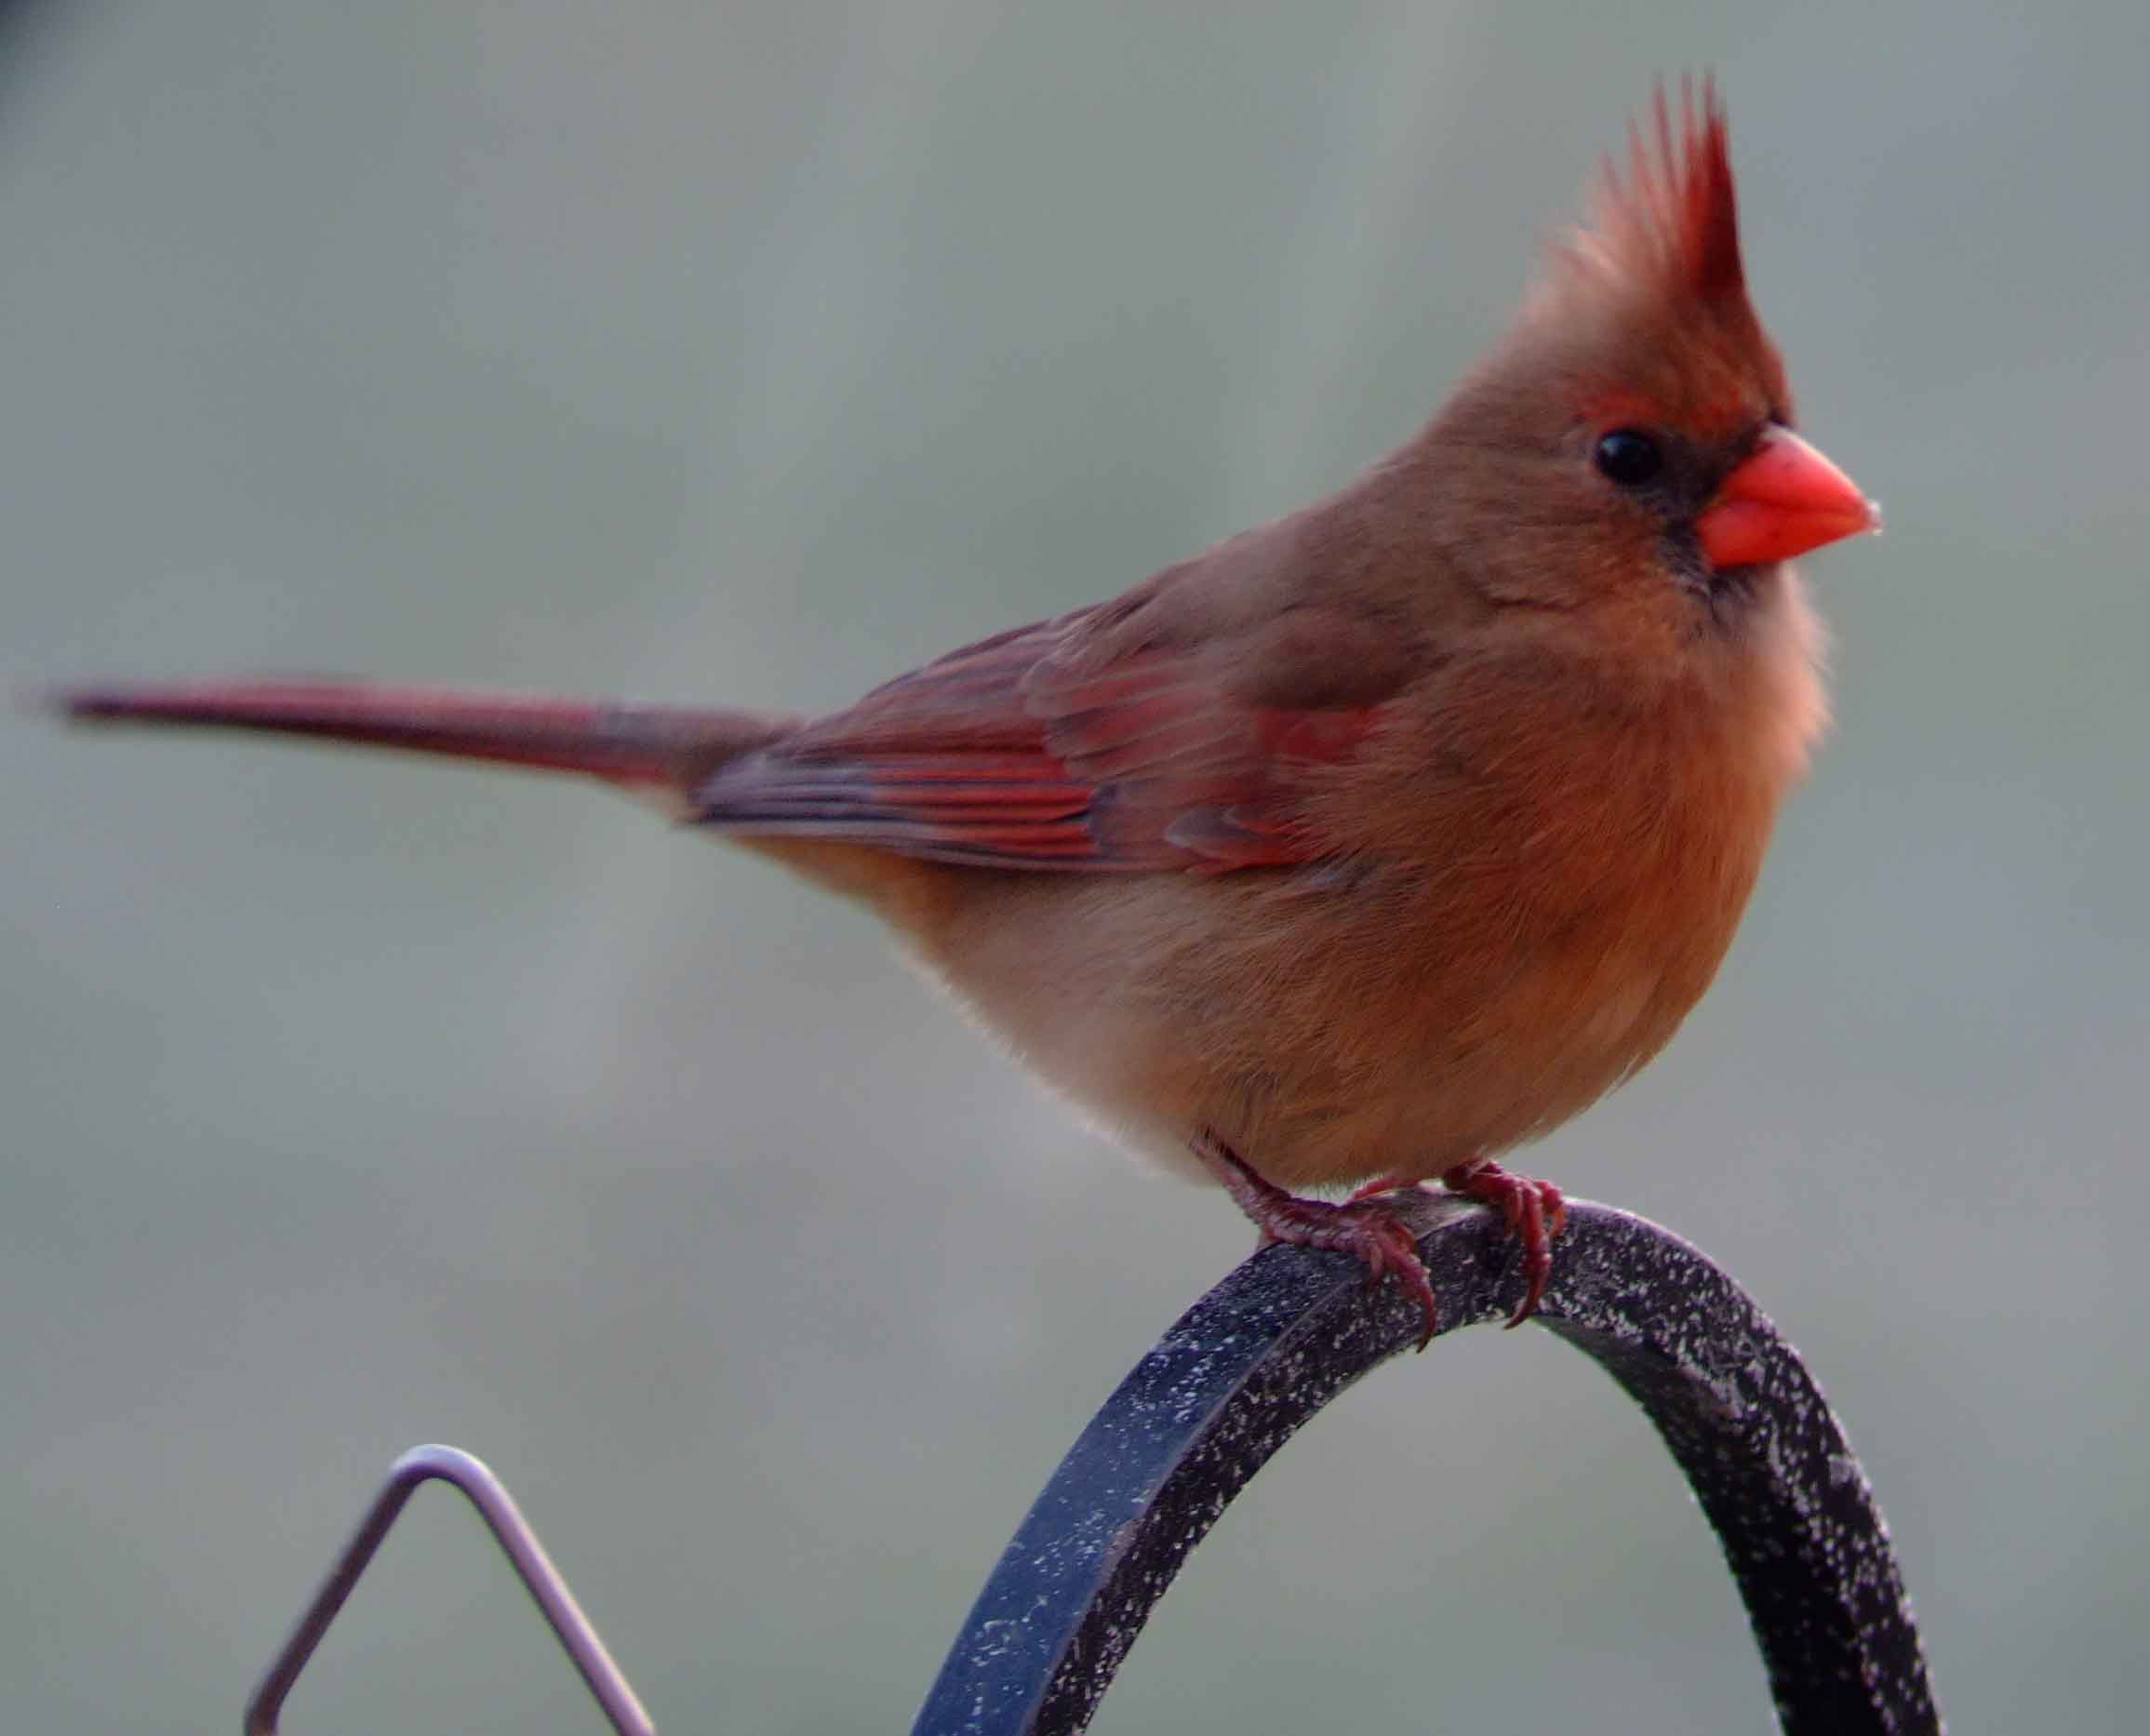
[0,0,2150,1736]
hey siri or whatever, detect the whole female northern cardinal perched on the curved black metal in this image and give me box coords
[60,88,1877,1336]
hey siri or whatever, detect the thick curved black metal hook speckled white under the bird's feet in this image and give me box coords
[914,1194,1942,1736]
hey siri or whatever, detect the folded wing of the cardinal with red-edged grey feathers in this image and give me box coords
[697,611,1374,874]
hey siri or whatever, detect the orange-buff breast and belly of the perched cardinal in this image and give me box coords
[894,662,1776,1187]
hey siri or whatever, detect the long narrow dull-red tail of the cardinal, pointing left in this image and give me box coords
[46,677,791,794]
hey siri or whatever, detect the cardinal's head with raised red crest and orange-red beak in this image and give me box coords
[1428,86,1879,684]
